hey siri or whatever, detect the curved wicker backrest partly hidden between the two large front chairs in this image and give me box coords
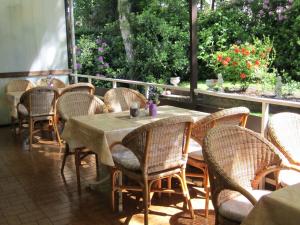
[191,107,250,146]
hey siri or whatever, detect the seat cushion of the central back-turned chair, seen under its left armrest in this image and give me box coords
[112,147,141,171]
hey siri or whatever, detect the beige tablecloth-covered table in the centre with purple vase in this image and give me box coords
[62,105,208,166]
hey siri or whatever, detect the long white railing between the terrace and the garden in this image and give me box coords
[71,74,300,135]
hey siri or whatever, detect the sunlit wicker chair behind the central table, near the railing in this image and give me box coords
[104,88,147,112]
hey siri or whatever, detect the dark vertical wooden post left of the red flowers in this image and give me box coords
[189,0,198,103]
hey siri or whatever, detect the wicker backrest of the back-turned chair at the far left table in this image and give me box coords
[20,87,58,116]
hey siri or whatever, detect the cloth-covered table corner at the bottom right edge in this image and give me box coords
[242,183,300,225]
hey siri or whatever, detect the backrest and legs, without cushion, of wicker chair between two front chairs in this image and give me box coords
[187,107,250,218]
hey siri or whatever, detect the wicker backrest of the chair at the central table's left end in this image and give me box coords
[57,92,104,121]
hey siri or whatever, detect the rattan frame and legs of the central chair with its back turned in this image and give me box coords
[110,116,194,225]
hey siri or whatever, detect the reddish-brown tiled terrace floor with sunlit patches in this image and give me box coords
[0,127,214,225]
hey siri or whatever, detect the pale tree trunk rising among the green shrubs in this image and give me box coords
[118,0,134,76]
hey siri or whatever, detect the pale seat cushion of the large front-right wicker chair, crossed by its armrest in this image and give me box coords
[219,190,271,222]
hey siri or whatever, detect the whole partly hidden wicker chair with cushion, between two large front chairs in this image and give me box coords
[187,107,250,217]
